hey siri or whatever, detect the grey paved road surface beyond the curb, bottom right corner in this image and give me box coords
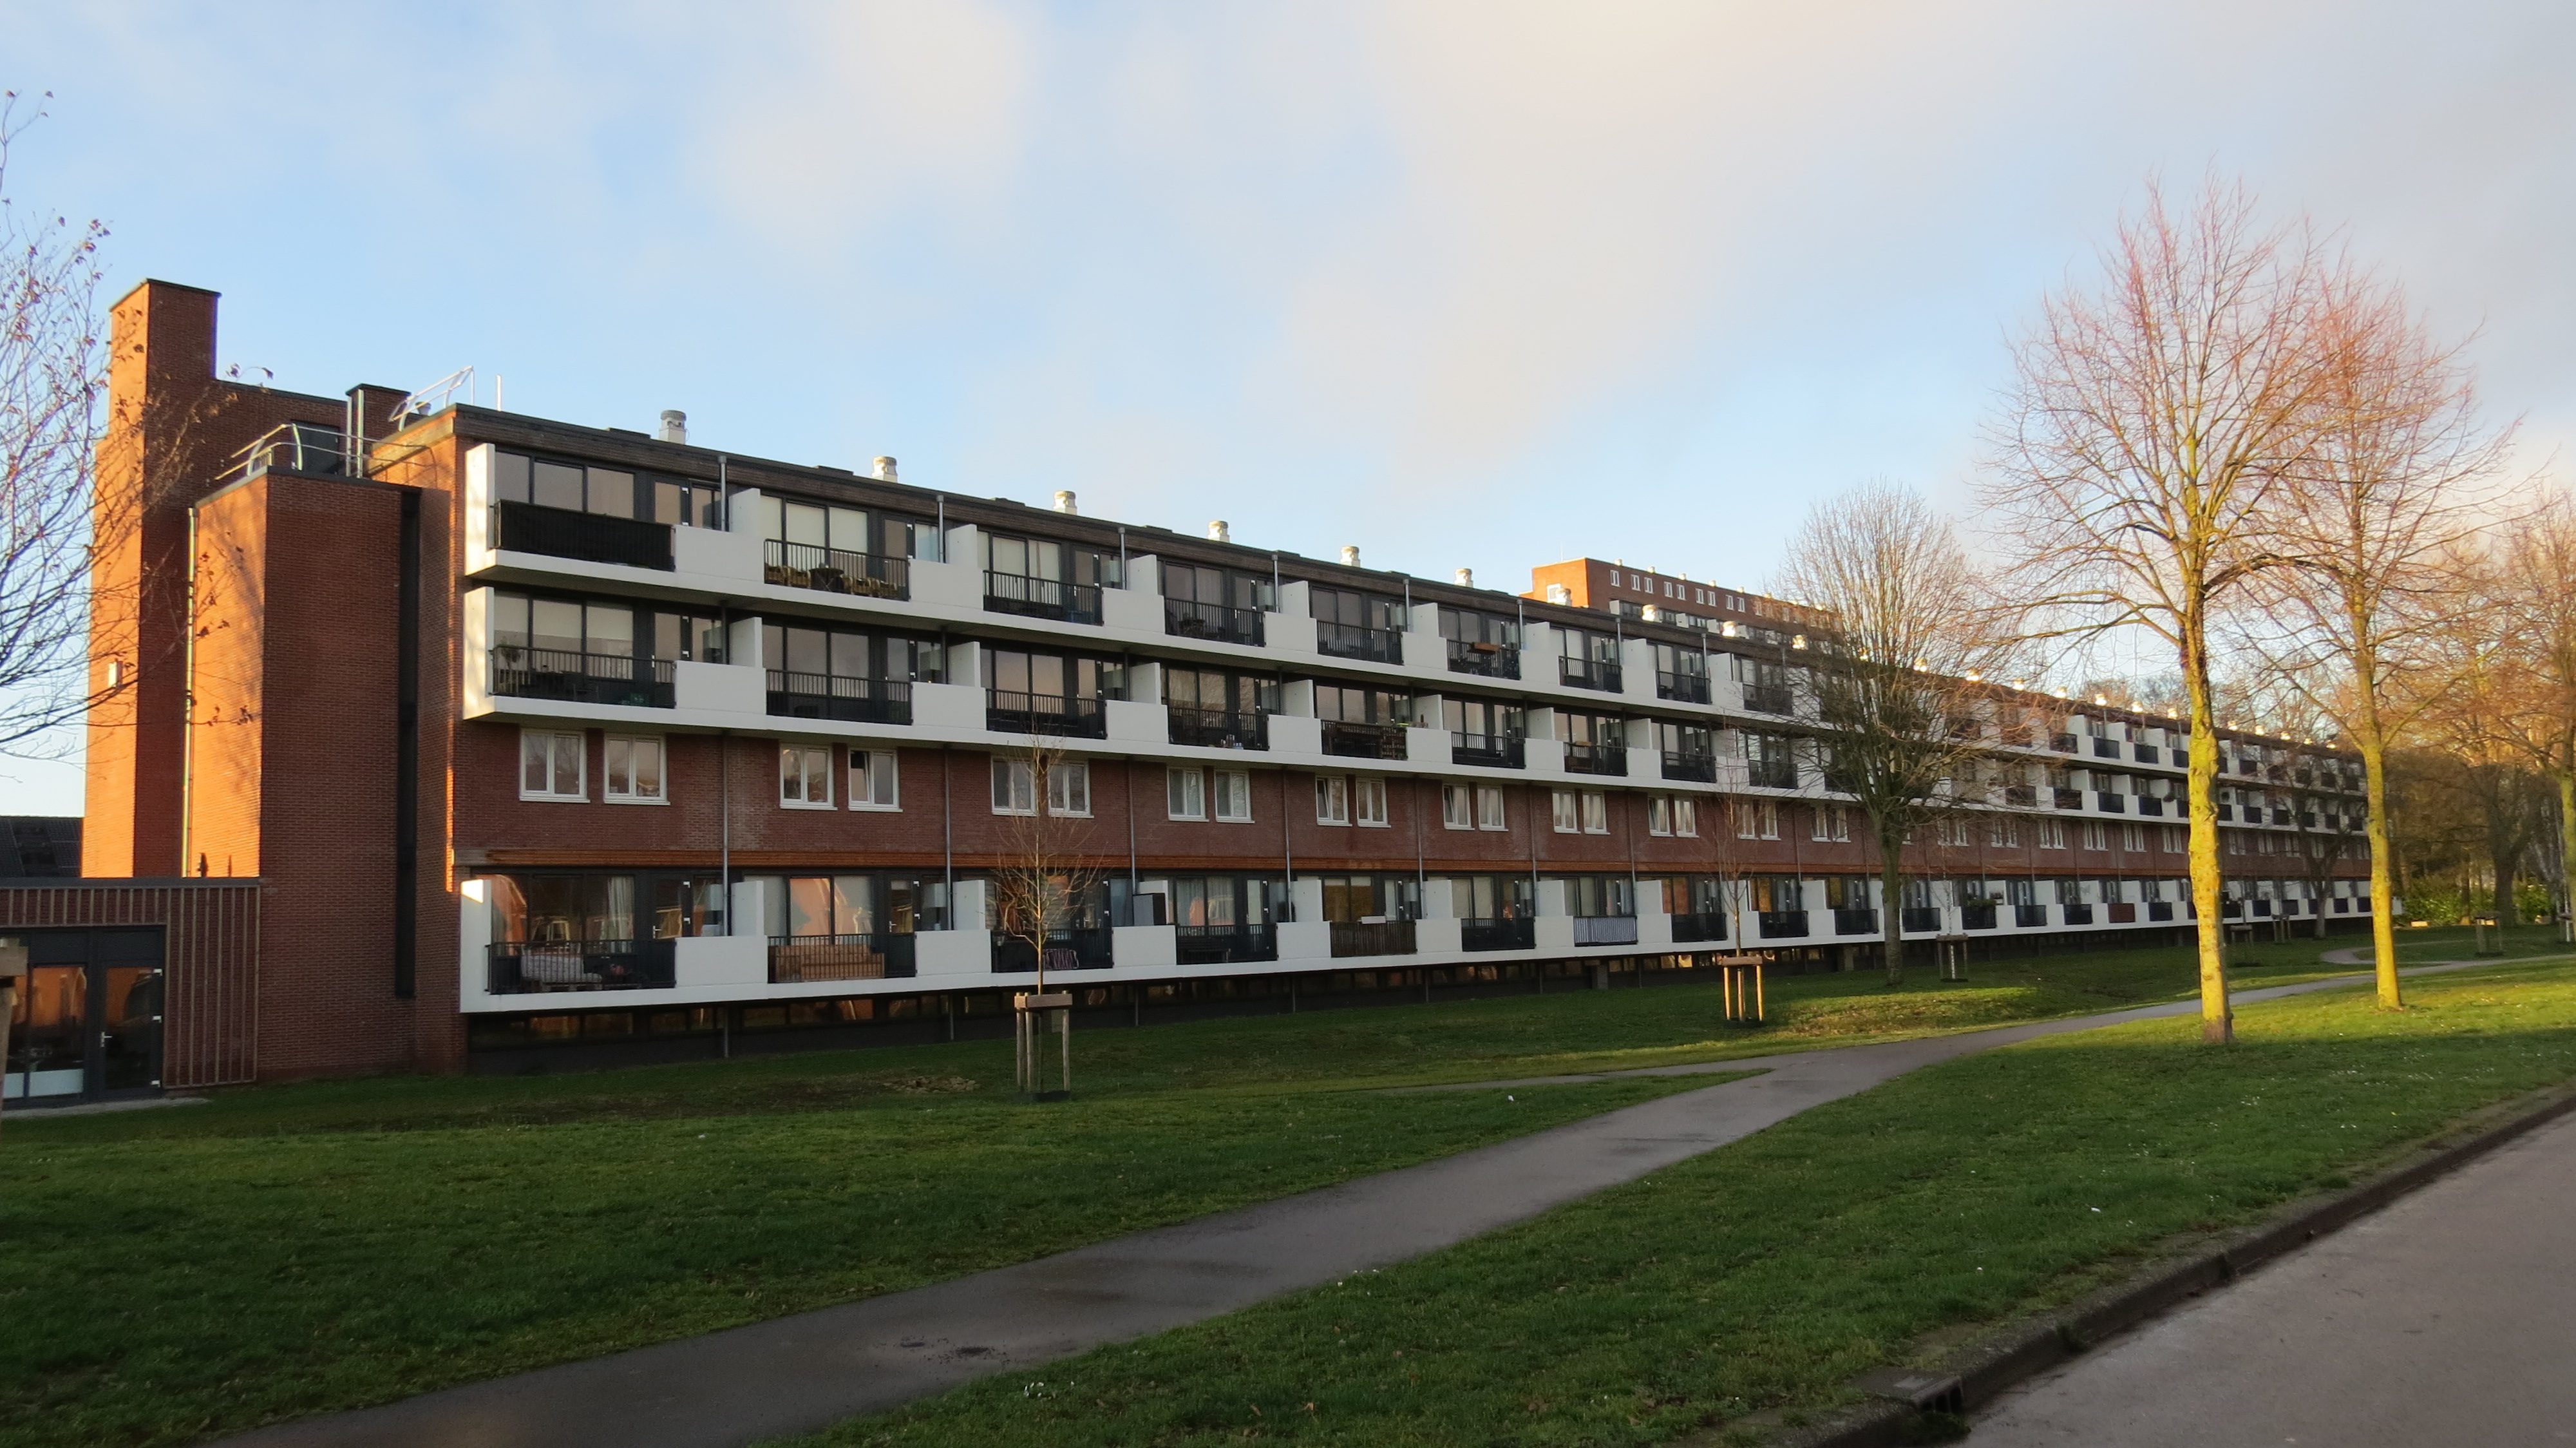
[1971,1098,2576,1448]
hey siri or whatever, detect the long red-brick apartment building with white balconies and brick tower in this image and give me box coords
[15,283,2362,1080]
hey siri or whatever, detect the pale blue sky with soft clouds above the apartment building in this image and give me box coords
[0,0,2576,812]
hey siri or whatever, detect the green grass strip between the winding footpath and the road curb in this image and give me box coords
[809,964,2576,1448]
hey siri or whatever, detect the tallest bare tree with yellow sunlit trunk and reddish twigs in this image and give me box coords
[1984,186,2326,1041]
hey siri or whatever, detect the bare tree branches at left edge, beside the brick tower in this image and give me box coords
[0,93,124,755]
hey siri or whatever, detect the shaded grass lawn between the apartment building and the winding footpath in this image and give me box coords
[0,922,2463,1445]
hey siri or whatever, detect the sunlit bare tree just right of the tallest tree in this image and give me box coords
[2241,278,2512,989]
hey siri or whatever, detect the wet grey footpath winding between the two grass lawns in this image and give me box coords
[229,961,2494,1448]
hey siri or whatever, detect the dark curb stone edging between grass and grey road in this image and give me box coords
[1770,1082,2576,1448]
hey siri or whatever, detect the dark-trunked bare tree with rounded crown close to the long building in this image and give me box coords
[1780,484,2002,984]
